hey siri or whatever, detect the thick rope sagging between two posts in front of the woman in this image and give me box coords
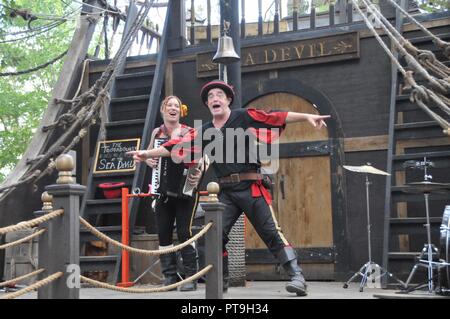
[80,217,212,256]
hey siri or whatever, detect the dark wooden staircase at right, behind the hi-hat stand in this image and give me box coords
[383,33,450,284]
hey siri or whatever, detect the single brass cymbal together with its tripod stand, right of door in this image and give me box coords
[343,163,405,292]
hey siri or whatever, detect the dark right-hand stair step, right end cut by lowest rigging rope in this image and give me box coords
[395,121,447,139]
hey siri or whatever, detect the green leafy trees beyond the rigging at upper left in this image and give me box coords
[0,0,79,182]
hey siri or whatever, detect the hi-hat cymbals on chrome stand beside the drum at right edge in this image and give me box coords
[404,157,450,293]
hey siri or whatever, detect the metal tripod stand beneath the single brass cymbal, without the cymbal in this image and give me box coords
[343,173,405,292]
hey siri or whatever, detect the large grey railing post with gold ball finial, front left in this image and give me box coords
[38,154,86,299]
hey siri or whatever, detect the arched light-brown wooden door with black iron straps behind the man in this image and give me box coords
[245,93,334,280]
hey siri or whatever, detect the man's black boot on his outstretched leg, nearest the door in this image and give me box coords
[278,246,307,296]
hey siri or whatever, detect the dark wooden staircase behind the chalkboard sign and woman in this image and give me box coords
[80,1,170,283]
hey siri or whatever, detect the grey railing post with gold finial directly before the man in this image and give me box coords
[201,183,225,299]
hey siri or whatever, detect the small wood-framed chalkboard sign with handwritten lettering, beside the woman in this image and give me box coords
[94,138,141,174]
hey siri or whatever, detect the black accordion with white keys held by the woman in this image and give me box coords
[150,138,197,197]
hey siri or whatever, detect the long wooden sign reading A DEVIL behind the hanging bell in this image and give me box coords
[197,32,359,78]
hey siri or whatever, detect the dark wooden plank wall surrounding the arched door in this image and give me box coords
[167,21,448,280]
